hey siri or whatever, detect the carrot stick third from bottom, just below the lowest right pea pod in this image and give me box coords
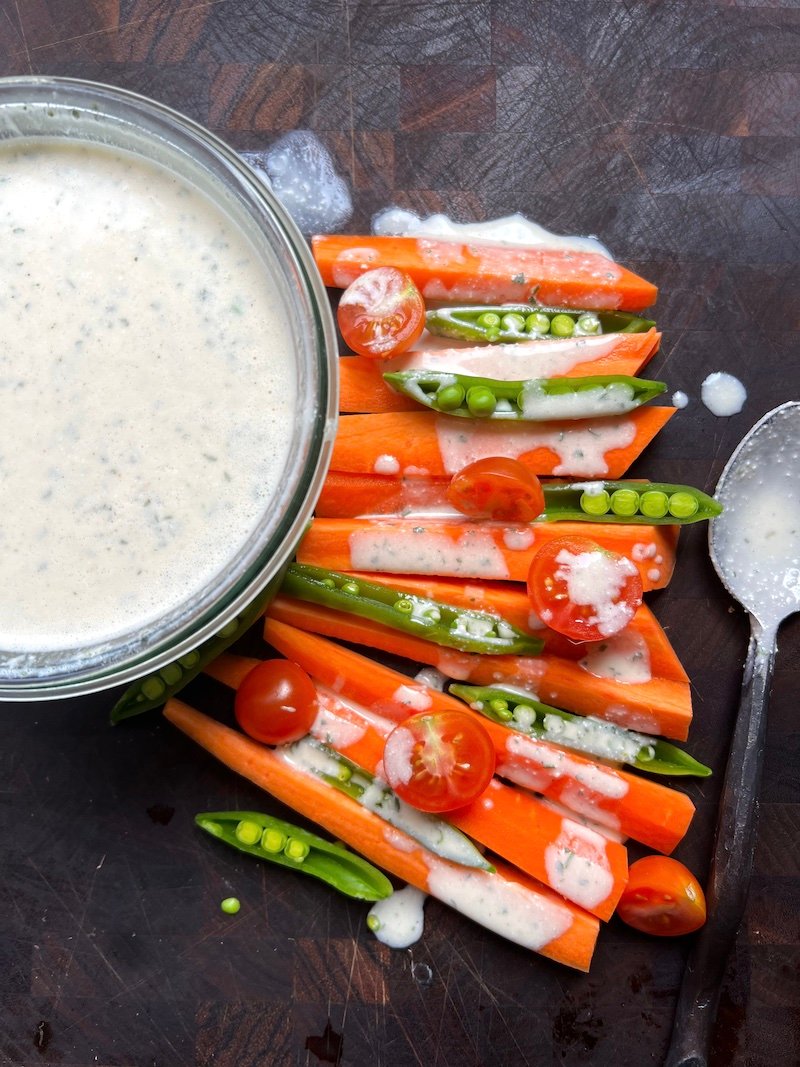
[254,618,694,853]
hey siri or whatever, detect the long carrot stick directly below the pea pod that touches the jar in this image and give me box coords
[269,595,691,740]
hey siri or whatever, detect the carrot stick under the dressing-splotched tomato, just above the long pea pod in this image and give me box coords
[341,571,689,684]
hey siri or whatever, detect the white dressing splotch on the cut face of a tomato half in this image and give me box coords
[555,548,638,636]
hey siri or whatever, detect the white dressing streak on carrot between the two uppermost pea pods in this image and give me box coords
[384,334,618,382]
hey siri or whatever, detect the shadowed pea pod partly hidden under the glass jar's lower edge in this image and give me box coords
[110,572,283,726]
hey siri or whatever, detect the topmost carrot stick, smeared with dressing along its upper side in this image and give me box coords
[311,235,658,312]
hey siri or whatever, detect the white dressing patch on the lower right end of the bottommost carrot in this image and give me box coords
[427,858,573,951]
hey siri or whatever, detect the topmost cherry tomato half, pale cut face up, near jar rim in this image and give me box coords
[336,267,425,360]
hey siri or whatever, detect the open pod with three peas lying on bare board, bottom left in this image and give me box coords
[194,811,393,901]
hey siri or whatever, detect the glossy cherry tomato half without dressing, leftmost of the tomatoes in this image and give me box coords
[234,659,317,745]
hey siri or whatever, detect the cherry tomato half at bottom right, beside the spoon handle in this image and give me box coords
[617,856,705,937]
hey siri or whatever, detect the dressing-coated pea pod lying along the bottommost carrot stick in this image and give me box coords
[281,737,494,871]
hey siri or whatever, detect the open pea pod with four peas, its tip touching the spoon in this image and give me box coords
[539,481,722,526]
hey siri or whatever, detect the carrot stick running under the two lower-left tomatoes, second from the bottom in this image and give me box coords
[199,655,627,920]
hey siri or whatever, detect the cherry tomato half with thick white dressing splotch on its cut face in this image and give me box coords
[528,537,642,641]
